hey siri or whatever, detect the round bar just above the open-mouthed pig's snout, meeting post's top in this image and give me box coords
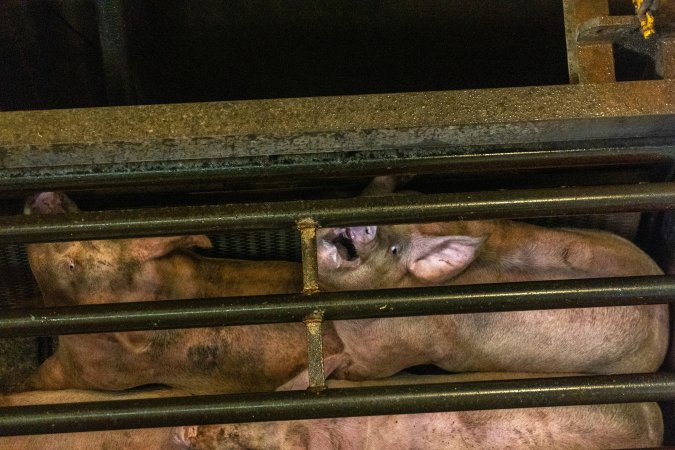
[0,183,675,243]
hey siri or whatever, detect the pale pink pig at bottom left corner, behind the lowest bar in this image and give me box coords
[0,390,190,450]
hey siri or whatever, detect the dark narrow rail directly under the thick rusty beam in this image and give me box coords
[0,144,675,193]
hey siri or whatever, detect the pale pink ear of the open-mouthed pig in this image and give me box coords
[408,235,485,283]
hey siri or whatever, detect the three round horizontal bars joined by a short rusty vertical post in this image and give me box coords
[0,179,675,435]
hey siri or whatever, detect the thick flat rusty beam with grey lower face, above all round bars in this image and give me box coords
[0,80,675,172]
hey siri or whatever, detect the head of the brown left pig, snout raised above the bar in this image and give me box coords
[24,192,211,306]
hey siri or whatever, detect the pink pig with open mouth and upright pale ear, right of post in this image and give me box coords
[310,177,669,379]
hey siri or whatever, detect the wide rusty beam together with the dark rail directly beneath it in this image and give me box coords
[0,80,675,193]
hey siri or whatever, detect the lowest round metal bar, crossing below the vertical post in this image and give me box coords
[0,373,675,436]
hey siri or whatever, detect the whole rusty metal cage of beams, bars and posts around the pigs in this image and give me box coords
[0,0,675,443]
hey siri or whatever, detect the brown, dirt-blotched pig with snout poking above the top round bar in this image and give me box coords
[16,192,320,393]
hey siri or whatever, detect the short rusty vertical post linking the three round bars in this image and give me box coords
[296,218,326,391]
